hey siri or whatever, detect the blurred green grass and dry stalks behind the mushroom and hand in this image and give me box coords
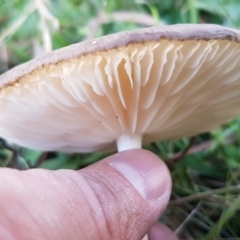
[0,0,240,239]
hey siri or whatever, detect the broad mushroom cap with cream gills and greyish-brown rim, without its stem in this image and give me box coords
[0,24,240,152]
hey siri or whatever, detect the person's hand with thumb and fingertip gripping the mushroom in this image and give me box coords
[0,149,177,240]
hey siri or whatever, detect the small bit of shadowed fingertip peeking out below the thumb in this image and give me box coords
[148,222,178,240]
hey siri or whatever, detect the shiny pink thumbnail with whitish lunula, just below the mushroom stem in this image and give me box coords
[108,149,172,202]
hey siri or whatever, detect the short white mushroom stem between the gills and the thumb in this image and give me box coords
[117,135,142,152]
